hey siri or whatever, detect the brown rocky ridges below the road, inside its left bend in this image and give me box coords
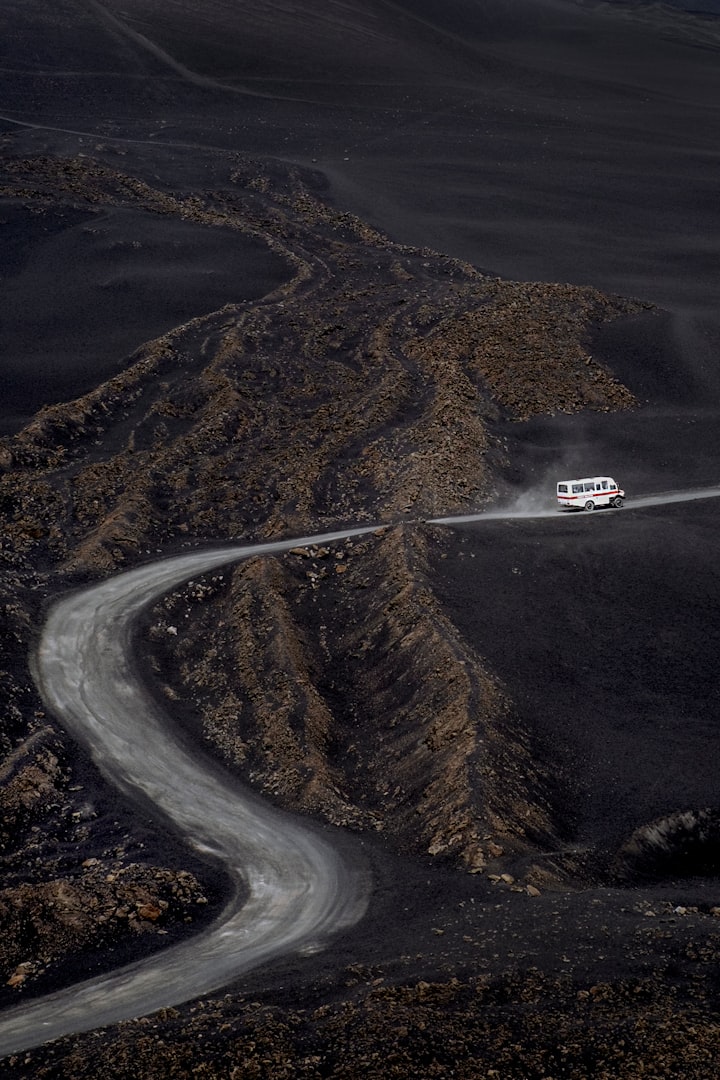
[141,526,554,873]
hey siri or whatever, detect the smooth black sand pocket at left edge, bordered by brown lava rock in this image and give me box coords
[0,200,288,434]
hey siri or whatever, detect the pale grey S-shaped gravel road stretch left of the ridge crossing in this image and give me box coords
[0,526,377,1056]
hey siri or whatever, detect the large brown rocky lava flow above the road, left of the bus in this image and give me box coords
[0,159,647,572]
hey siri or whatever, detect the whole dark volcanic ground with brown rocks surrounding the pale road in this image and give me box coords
[0,0,720,1080]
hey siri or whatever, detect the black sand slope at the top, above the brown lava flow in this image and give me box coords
[0,0,720,304]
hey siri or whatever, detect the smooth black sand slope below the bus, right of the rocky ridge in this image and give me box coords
[437,500,720,864]
